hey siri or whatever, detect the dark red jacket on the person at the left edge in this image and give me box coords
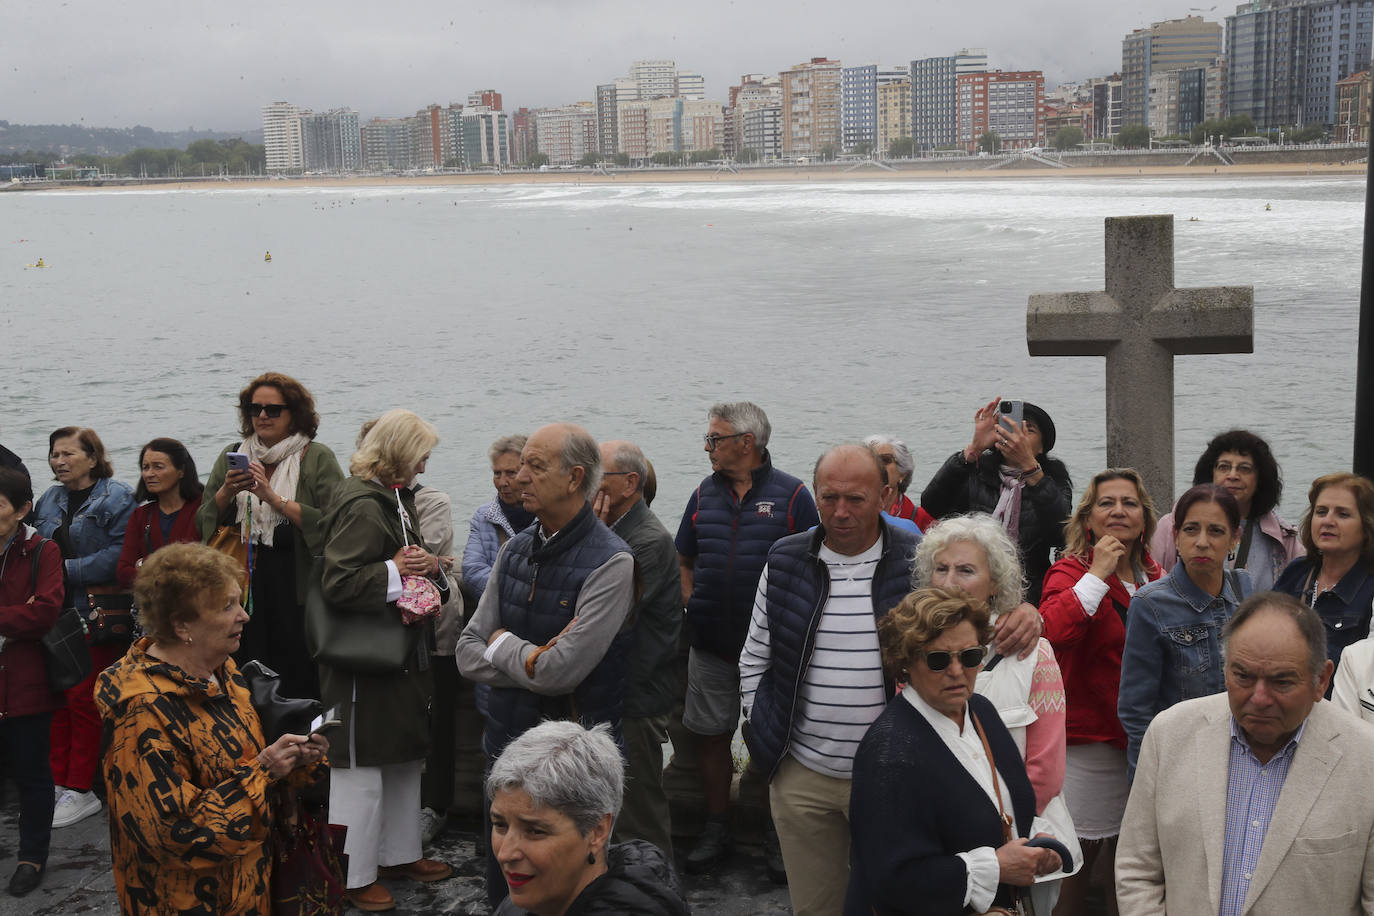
[0,527,67,720]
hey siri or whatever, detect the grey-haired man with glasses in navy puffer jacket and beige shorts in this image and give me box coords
[676,401,820,883]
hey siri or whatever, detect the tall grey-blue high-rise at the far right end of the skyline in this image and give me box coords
[1226,0,1374,130]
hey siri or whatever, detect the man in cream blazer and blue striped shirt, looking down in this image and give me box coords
[1116,592,1374,916]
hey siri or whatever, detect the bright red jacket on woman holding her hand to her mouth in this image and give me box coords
[1040,552,1161,750]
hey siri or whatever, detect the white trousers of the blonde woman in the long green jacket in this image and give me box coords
[330,761,425,890]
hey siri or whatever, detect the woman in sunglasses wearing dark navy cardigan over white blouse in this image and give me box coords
[845,590,1062,916]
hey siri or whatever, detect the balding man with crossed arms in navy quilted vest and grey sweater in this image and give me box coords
[455,423,635,904]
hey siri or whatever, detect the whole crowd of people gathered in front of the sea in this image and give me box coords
[0,372,1374,916]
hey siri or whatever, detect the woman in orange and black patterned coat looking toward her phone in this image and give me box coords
[96,544,328,916]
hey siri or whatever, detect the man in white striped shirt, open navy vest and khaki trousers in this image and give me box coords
[739,445,921,916]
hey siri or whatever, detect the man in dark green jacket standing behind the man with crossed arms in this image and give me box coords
[594,441,683,861]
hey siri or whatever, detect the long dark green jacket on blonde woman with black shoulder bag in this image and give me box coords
[320,477,433,766]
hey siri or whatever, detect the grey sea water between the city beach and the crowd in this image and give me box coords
[0,177,1364,542]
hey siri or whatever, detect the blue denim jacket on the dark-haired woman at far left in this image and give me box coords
[33,478,135,611]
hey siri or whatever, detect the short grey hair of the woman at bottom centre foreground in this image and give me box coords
[486,721,625,836]
